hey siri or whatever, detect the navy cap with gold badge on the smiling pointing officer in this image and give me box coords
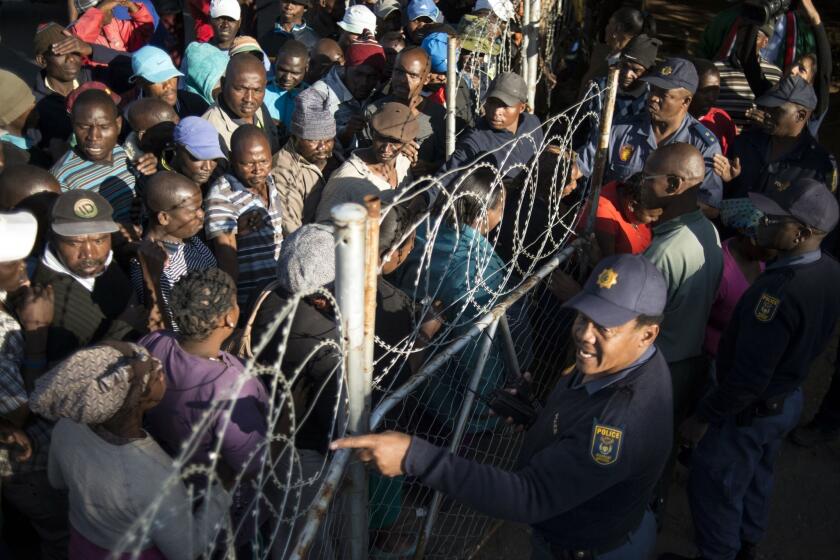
[563,255,668,328]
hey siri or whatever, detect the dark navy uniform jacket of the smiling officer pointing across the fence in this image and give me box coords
[405,348,674,549]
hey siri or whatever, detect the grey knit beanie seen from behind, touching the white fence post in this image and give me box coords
[277,224,335,294]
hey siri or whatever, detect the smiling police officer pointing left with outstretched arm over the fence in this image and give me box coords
[331,255,673,560]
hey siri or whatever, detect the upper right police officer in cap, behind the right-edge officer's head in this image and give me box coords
[718,76,837,198]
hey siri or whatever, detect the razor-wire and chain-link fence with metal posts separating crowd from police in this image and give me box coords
[106,2,617,560]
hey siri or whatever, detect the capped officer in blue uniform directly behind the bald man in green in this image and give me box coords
[578,58,723,208]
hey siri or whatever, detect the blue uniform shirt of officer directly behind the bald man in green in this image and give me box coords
[578,112,723,208]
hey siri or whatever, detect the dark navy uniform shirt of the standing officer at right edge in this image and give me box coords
[697,251,840,422]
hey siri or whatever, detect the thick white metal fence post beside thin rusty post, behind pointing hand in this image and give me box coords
[331,203,371,560]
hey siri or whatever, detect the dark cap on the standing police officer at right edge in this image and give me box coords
[748,179,840,233]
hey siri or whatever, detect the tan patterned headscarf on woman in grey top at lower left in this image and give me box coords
[29,342,153,425]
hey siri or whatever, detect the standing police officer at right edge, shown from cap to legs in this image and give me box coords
[669,179,840,560]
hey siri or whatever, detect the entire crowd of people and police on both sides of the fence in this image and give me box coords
[0,0,840,560]
